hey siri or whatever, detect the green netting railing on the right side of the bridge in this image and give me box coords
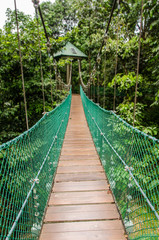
[81,88,159,240]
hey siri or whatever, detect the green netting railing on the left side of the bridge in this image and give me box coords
[0,89,71,240]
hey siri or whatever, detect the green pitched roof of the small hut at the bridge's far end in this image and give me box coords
[54,42,87,59]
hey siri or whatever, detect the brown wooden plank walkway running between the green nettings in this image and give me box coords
[40,95,126,240]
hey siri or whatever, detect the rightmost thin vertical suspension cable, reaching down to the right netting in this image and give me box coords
[133,0,144,127]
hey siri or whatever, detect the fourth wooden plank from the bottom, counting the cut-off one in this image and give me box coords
[53,180,108,192]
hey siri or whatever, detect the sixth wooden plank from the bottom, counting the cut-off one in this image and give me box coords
[57,165,104,173]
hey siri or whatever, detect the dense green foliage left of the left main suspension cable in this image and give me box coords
[0,9,67,143]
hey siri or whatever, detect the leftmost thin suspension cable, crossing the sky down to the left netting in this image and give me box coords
[14,0,29,130]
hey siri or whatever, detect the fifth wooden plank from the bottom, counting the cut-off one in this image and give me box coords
[55,172,106,182]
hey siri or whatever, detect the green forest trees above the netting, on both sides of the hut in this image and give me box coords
[0,0,159,143]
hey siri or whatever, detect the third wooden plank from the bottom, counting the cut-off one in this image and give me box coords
[49,191,114,205]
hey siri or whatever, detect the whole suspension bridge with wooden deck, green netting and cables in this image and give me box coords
[0,1,159,240]
